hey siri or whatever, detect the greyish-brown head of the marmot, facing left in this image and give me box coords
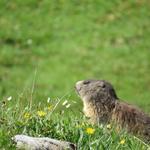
[75,80,118,106]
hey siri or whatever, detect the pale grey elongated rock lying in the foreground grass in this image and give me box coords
[12,135,76,150]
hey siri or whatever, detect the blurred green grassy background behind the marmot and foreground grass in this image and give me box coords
[0,0,150,112]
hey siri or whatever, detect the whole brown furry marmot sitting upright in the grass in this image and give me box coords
[75,80,150,141]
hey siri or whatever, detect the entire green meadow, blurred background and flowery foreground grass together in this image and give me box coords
[0,0,150,150]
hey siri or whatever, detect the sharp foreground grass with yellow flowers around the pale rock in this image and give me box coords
[0,96,149,150]
